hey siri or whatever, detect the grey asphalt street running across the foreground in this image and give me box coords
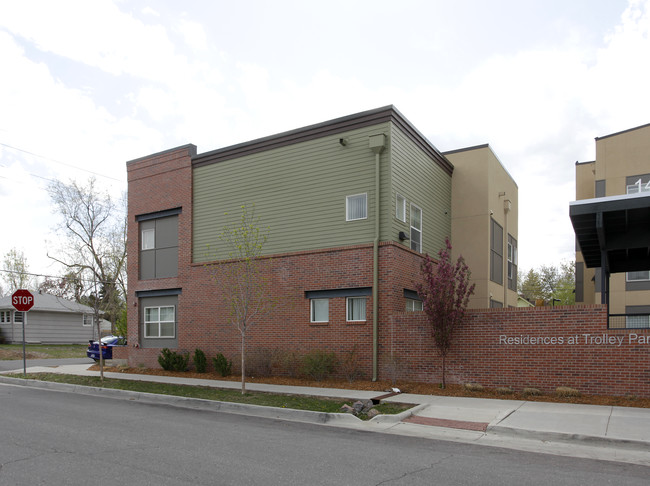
[0,384,650,485]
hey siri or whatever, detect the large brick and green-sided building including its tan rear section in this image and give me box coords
[127,106,517,378]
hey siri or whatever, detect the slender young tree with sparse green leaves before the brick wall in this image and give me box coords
[208,205,273,395]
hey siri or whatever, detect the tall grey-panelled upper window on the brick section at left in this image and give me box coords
[136,208,180,280]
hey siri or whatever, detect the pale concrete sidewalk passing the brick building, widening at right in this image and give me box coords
[0,364,650,466]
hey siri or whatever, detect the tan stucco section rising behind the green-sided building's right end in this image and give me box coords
[443,145,519,308]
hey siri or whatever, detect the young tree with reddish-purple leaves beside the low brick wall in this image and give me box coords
[415,238,474,388]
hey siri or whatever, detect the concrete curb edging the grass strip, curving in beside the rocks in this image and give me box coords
[0,375,416,427]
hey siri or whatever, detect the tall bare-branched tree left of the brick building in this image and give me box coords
[48,178,126,380]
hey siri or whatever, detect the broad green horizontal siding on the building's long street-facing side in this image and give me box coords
[193,123,390,262]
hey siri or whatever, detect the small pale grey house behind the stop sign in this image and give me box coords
[0,292,103,344]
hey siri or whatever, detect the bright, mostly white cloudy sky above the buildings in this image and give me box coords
[0,0,650,288]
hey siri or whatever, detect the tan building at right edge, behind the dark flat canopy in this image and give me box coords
[576,124,650,327]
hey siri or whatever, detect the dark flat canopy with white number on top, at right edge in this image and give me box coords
[569,193,650,273]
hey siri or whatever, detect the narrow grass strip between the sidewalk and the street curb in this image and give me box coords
[8,373,412,419]
